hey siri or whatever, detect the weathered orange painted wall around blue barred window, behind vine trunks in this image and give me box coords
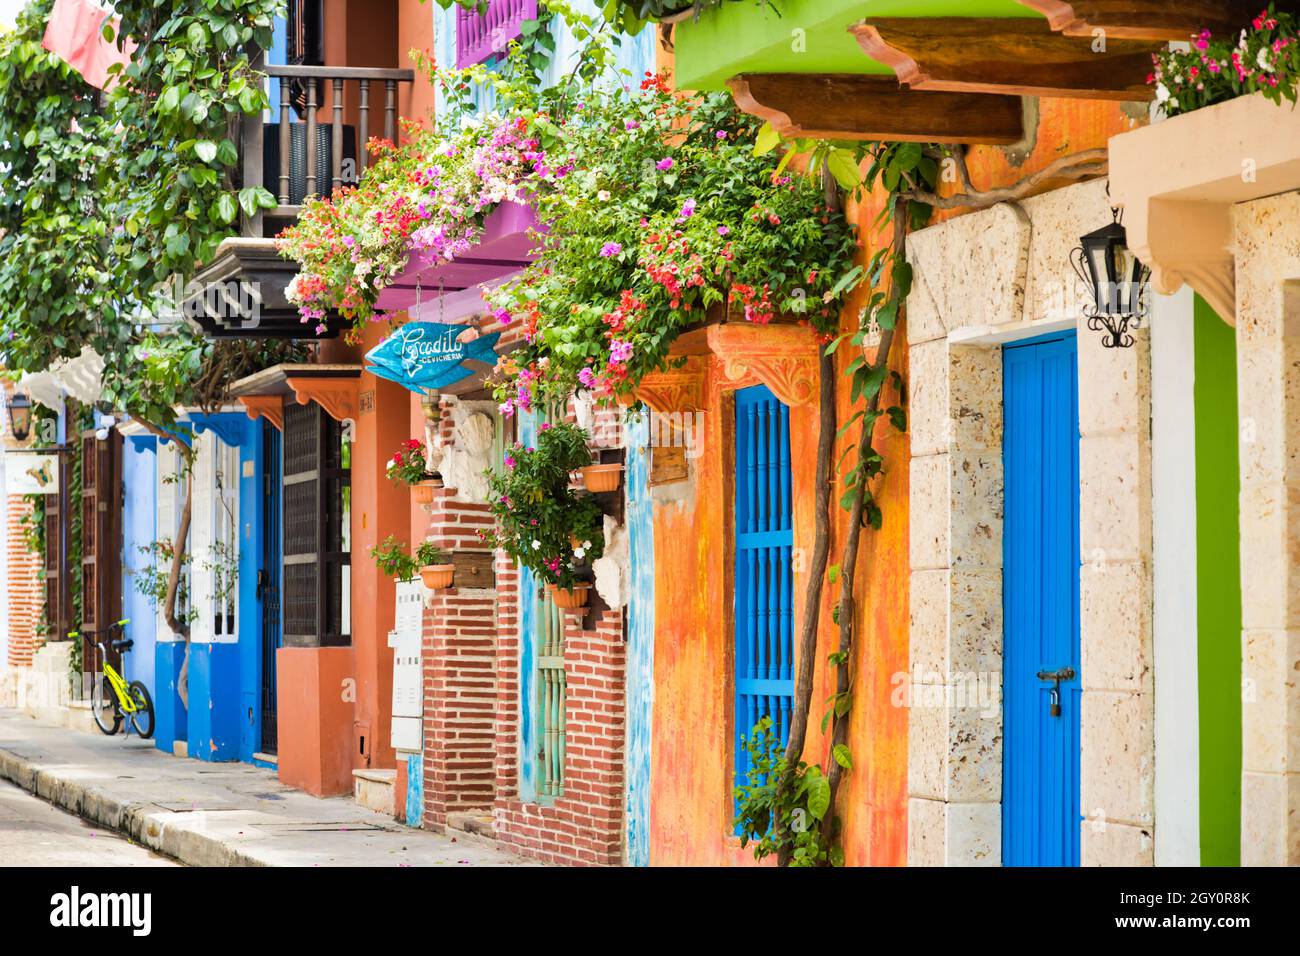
[650,85,1140,866]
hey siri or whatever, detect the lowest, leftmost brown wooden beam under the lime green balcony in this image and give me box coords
[727,73,1024,146]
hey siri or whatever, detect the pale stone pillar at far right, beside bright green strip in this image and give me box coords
[1234,193,1300,866]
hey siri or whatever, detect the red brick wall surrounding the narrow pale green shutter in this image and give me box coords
[495,611,625,866]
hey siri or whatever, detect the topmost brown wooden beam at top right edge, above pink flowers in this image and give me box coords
[1019,0,1263,42]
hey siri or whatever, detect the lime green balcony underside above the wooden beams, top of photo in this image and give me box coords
[673,0,1039,90]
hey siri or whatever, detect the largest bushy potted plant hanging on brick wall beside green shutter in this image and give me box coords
[484,423,605,607]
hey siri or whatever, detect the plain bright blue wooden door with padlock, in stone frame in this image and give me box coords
[1002,332,1080,866]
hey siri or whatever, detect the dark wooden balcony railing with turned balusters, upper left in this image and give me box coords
[242,65,415,238]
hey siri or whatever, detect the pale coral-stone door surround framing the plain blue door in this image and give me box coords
[907,181,1154,865]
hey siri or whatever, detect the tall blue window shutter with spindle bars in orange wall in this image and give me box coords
[735,385,794,783]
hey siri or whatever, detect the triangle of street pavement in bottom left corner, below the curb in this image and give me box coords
[0,780,178,866]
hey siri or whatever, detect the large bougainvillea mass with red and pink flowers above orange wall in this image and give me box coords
[489,75,857,415]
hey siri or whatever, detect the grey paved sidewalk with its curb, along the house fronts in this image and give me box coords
[0,710,528,866]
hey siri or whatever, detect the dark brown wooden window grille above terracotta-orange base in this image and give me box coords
[283,402,351,648]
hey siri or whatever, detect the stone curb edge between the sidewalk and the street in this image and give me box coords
[0,748,267,866]
